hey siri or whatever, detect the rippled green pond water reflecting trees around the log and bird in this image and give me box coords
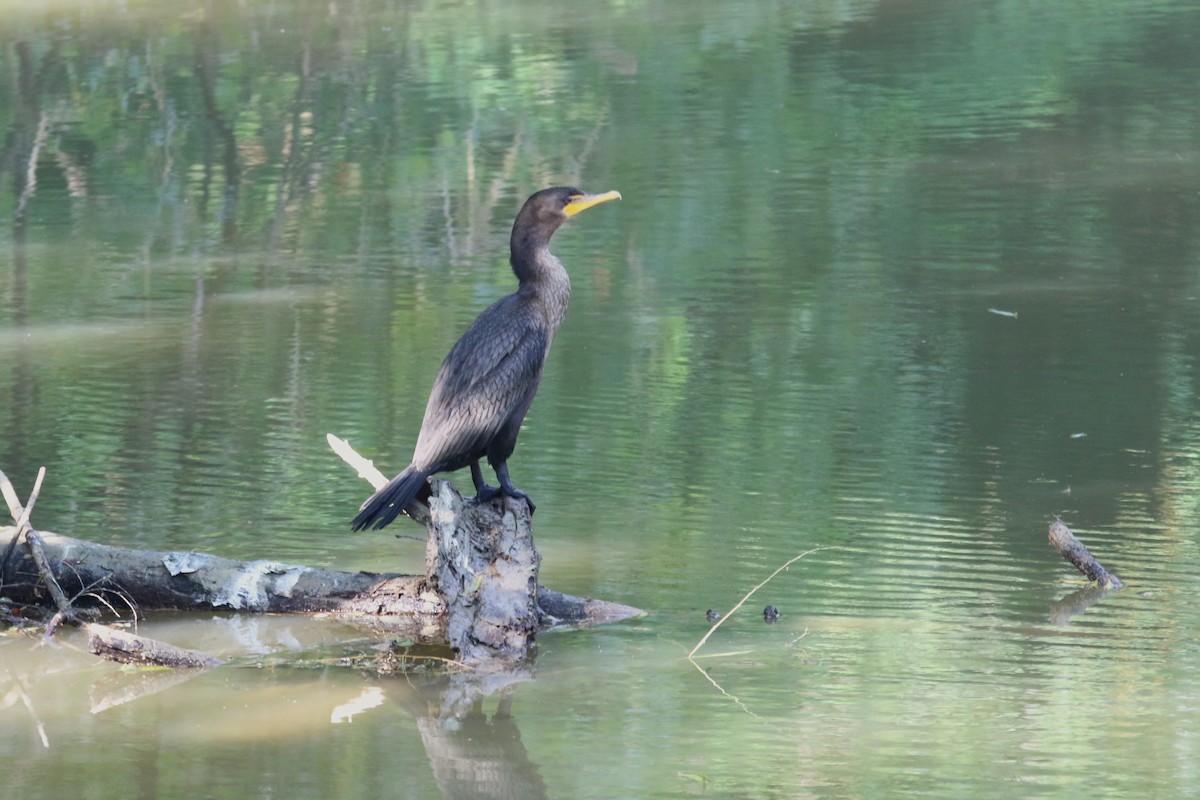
[0,0,1200,800]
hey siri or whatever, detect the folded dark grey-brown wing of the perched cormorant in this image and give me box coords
[413,295,550,469]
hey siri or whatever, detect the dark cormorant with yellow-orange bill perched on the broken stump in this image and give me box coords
[352,186,620,530]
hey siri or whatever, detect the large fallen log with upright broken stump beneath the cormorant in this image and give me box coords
[0,481,641,661]
